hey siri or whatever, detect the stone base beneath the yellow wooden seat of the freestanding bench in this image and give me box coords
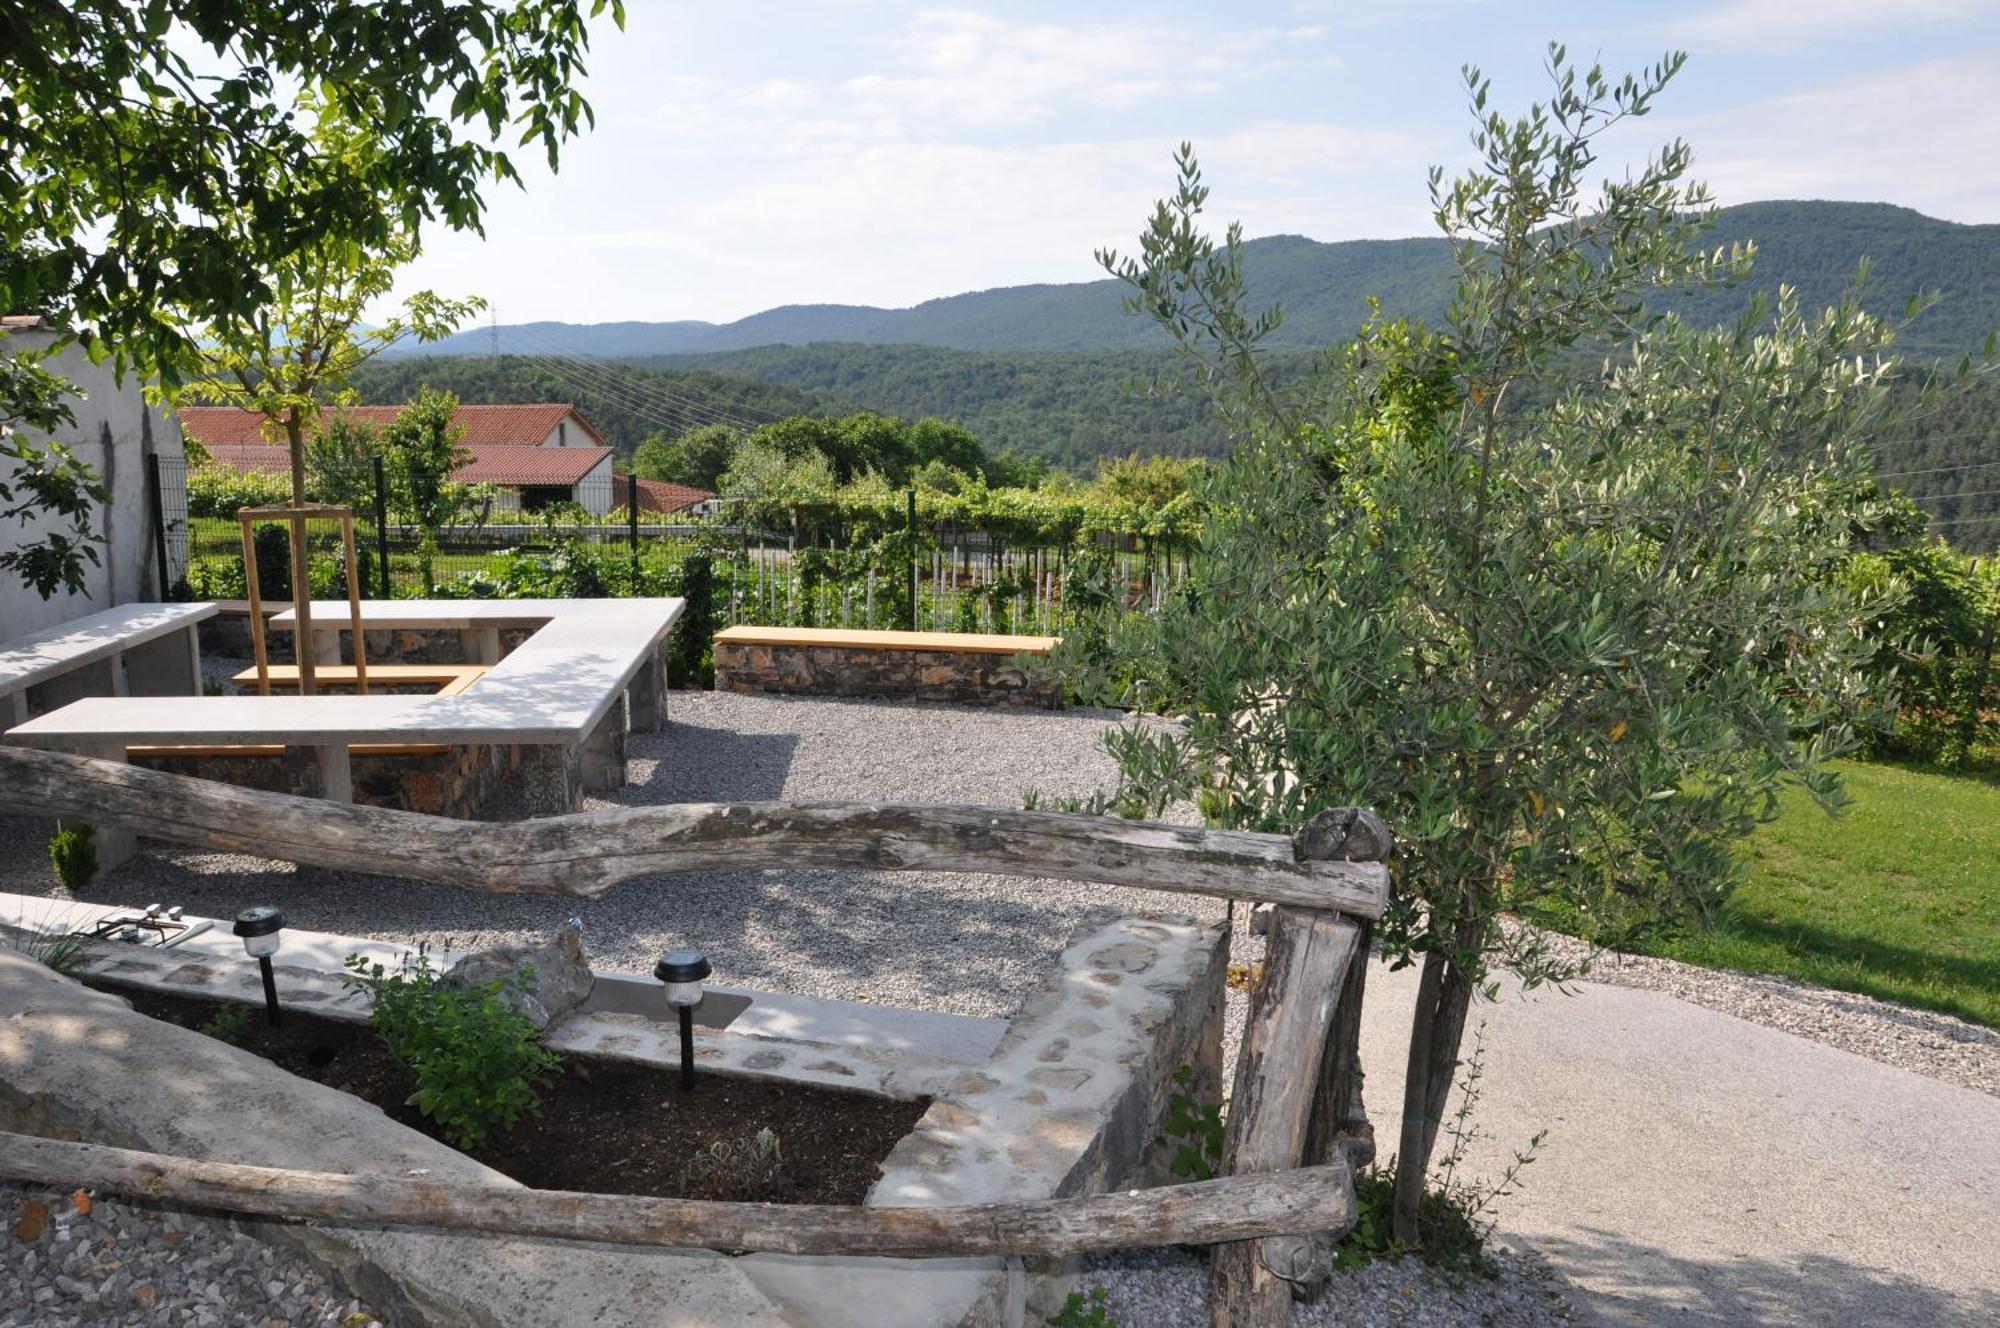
[716,640,1062,708]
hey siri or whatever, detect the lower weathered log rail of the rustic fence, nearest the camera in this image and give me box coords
[0,1132,1354,1258]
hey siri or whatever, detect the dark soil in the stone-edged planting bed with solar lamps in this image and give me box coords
[114,986,930,1204]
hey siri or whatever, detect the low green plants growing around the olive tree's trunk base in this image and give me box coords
[1334,1024,1548,1276]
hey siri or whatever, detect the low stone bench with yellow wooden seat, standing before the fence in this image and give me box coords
[716,626,1062,706]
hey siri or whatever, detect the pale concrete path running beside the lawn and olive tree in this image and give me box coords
[1362,964,2000,1328]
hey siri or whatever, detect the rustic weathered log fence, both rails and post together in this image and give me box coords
[0,746,1388,1328]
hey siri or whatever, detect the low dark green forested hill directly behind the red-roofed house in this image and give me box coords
[352,356,820,456]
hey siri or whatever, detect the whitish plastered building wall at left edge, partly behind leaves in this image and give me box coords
[0,328,186,640]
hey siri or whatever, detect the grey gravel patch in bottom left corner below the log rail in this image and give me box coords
[0,1182,376,1328]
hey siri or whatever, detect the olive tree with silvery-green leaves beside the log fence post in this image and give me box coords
[1078,46,1894,1246]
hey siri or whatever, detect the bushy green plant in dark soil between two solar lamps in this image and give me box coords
[342,946,562,1150]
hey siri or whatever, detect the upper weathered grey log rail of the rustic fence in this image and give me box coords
[0,746,1388,918]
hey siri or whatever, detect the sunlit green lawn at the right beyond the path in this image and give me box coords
[1646,762,2000,1028]
